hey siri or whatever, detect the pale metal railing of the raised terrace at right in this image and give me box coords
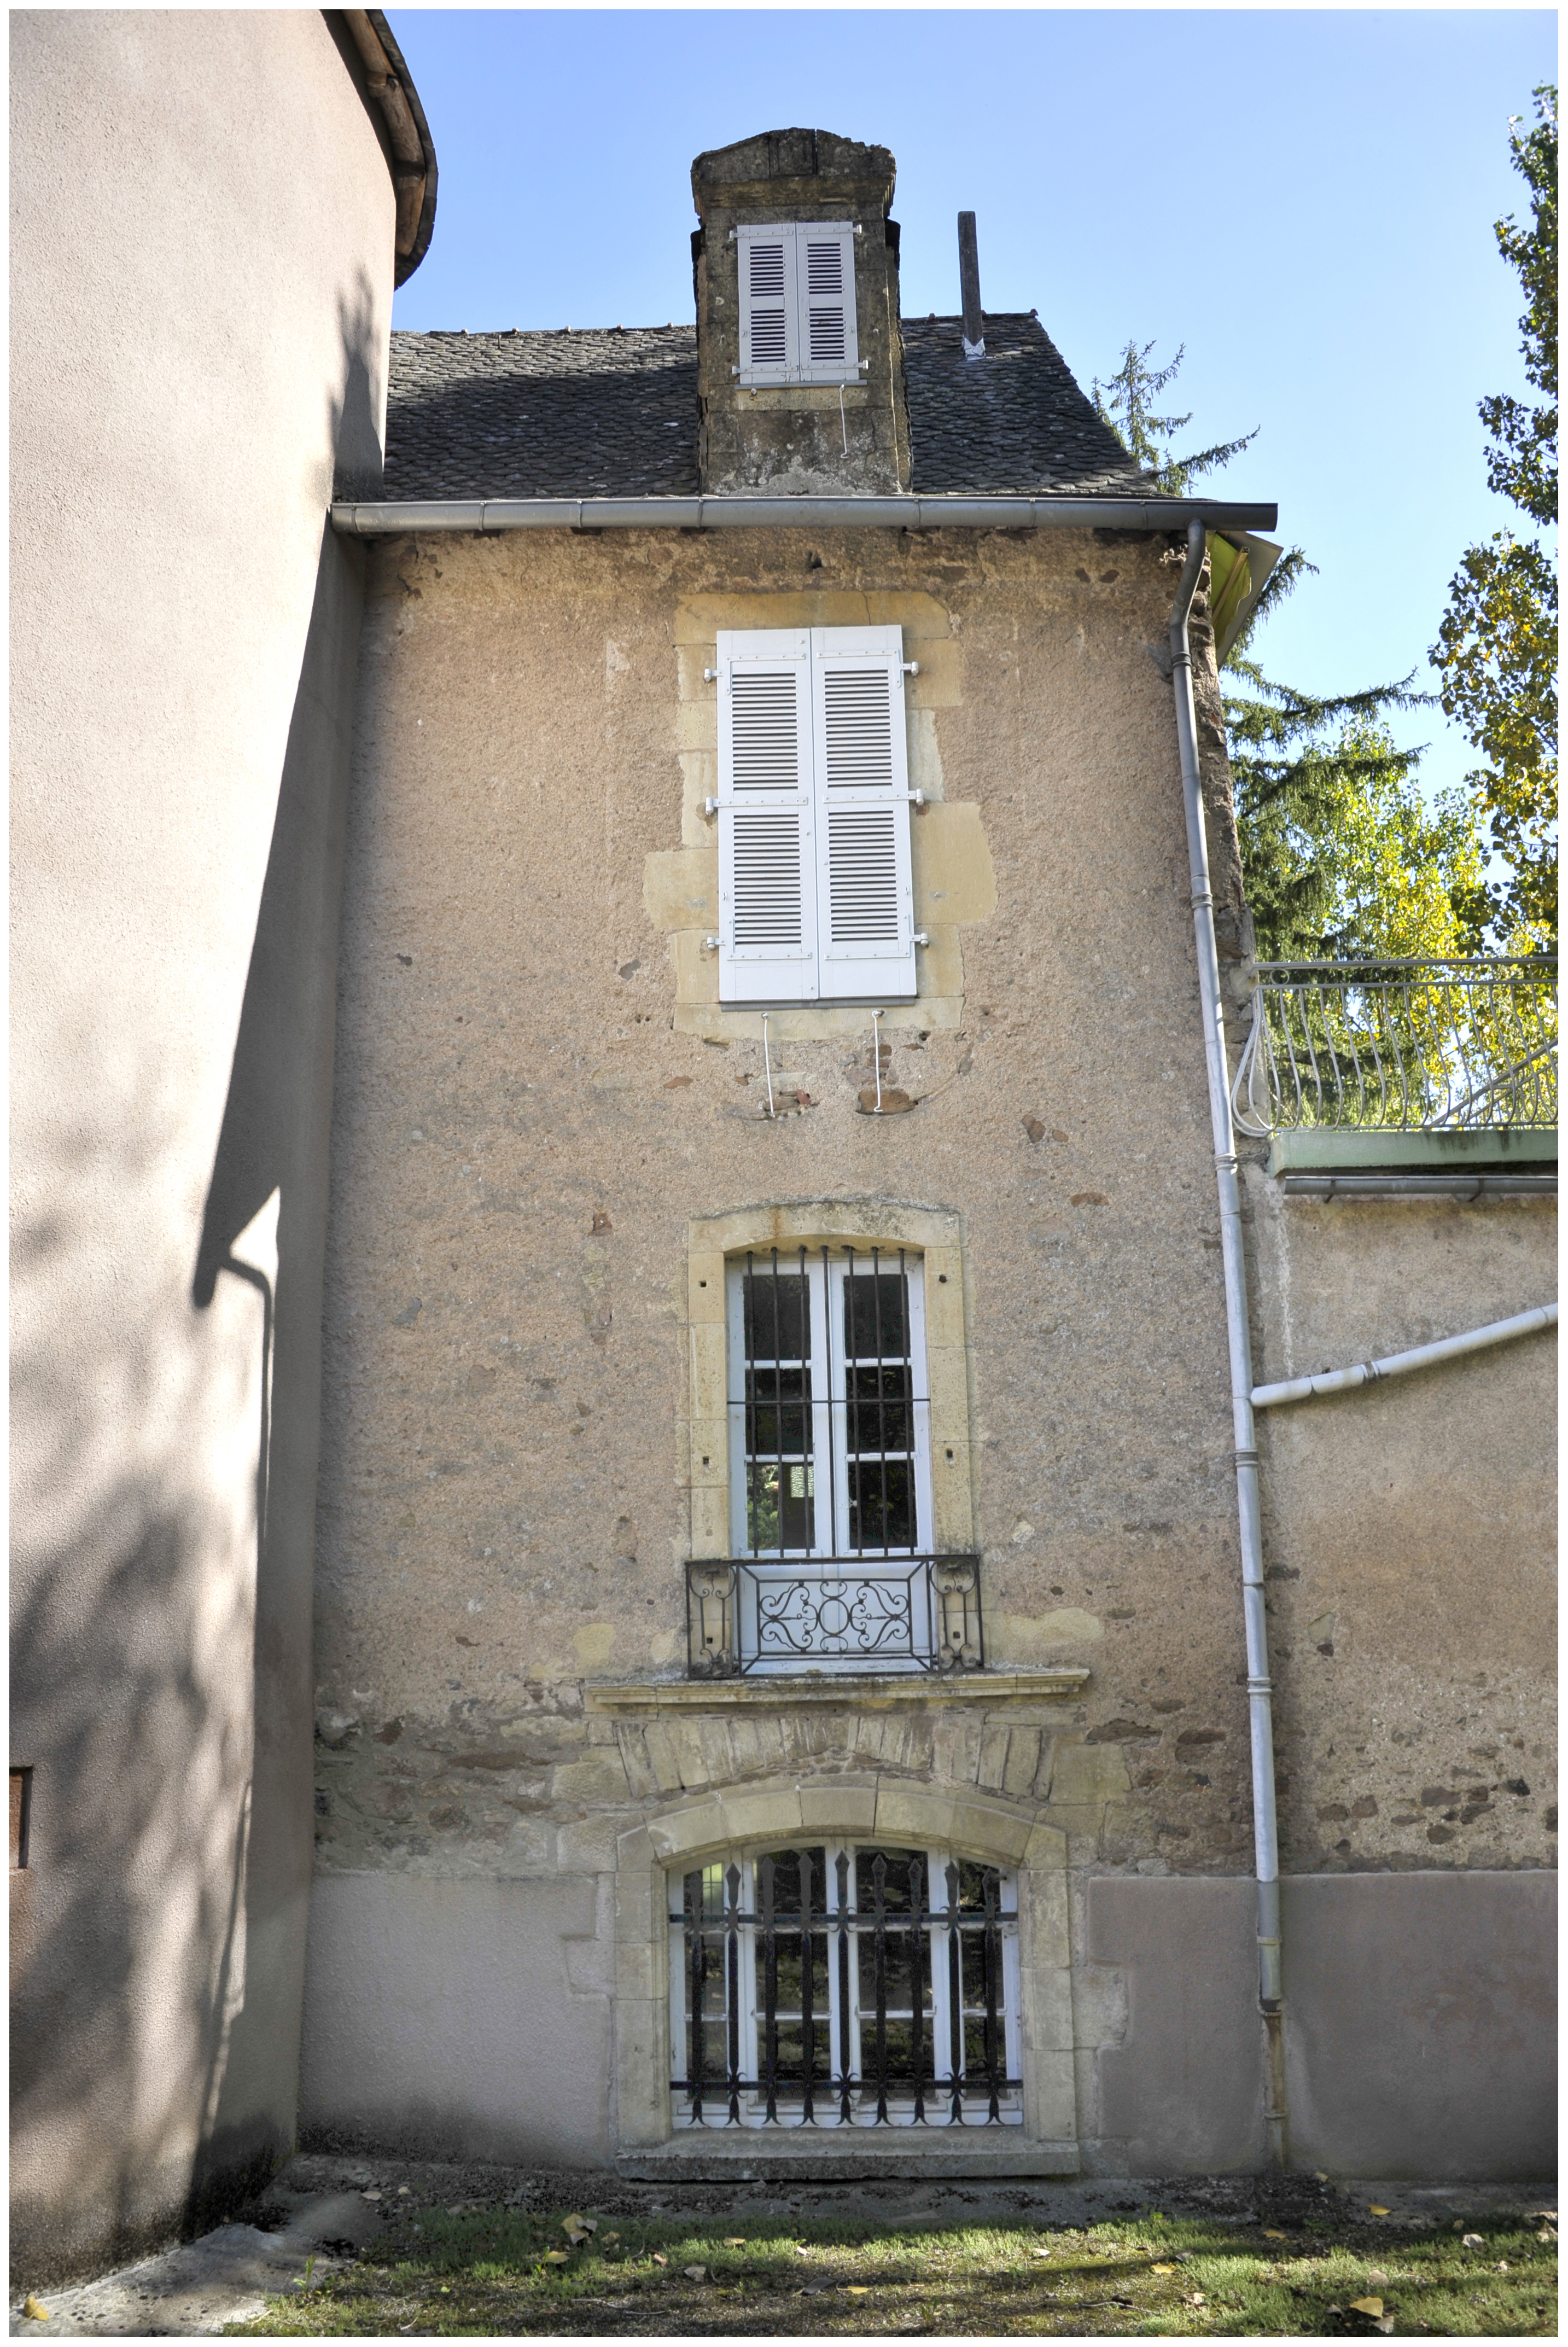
[1230,955,1557,1134]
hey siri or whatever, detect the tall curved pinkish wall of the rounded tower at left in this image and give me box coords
[11,11,392,2279]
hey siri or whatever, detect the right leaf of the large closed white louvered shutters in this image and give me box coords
[812,627,916,1002]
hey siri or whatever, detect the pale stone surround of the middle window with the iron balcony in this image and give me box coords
[685,1199,983,1568]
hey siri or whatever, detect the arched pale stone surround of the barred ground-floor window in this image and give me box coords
[613,1774,1077,2173]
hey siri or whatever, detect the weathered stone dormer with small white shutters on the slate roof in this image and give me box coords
[692,131,908,495]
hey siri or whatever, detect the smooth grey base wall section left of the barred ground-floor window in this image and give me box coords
[300,1873,613,2169]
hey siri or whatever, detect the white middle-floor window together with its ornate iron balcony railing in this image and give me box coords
[688,1247,983,1676]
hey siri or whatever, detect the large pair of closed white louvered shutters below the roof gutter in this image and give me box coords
[714,627,920,1005]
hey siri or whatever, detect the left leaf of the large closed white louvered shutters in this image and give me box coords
[718,627,817,1002]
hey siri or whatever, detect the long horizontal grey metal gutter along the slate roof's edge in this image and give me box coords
[331,495,1279,538]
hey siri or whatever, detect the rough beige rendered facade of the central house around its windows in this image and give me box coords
[303,533,1249,2154]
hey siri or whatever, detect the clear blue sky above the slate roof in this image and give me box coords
[389,9,1557,789]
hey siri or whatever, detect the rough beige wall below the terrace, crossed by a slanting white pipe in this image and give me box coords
[1249,1169,1557,1871]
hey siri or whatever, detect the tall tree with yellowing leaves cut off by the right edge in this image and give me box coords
[1430,82,1559,951]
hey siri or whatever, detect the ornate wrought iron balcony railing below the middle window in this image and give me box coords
[685,1556,983,1678]
